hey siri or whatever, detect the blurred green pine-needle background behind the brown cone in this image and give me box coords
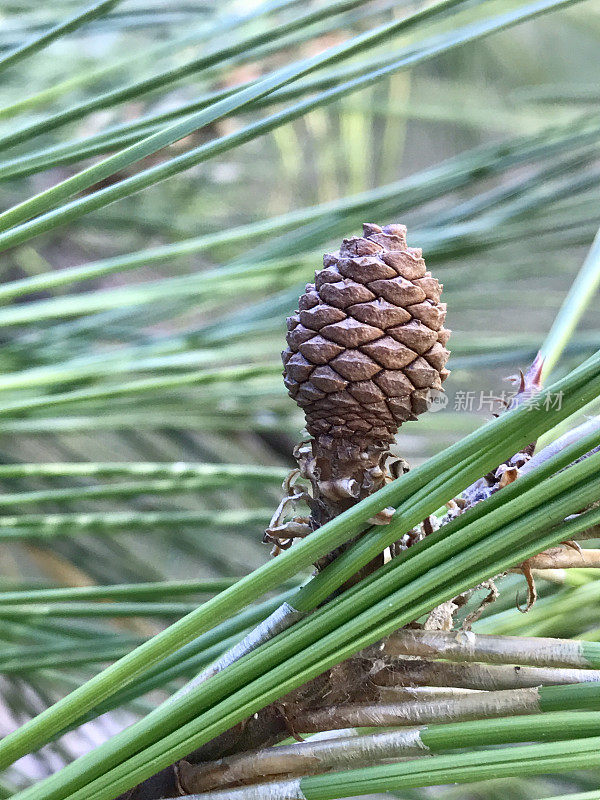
[0,0,600,800]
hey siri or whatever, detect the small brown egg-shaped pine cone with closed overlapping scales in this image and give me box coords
[282,224,450,446]
